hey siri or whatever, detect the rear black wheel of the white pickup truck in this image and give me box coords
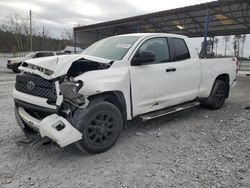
[202,80,227,110]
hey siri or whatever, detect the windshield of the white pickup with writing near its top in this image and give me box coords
[83,36,140,61]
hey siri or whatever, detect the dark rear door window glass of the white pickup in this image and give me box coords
[172,38,190,61]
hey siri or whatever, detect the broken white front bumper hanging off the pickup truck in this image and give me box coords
[15,106,82,147]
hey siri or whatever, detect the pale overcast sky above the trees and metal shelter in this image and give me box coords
[0,0,250,56]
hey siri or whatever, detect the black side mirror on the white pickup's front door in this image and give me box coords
[132,51,155,66]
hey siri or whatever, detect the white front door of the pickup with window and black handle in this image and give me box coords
[130,37,174,117]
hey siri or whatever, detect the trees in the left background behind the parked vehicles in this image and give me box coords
[0,15,73,53]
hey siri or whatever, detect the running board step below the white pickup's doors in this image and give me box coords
[139,101,200,121]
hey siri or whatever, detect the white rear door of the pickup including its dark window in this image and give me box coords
[168,38,201,104]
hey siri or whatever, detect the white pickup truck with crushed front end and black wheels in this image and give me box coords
[13,33,236,153]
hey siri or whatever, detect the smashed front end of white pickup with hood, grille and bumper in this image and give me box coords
[13,55,113,147]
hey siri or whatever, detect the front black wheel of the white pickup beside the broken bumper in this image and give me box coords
[72,101,123,154]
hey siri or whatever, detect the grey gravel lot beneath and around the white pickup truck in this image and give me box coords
[0,65,250,188]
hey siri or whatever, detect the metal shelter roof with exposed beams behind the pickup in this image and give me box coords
[74,0,250,38]
